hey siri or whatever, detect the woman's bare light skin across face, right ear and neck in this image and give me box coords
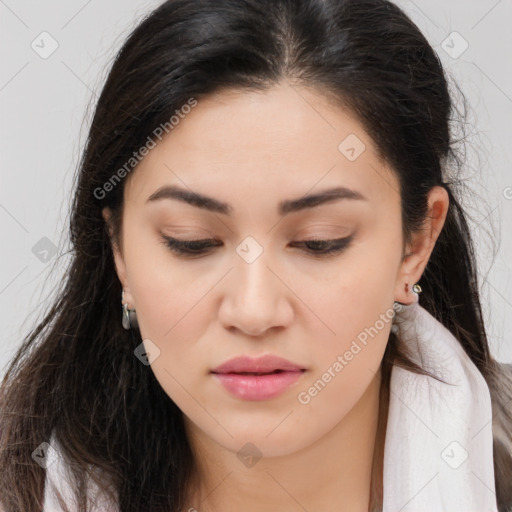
[103,83,449,512]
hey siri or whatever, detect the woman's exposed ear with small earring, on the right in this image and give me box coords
[395,186,450,304]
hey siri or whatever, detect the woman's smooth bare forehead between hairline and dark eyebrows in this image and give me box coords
[125,84,398,211]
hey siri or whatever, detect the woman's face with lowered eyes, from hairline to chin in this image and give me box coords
[105,85,415,455]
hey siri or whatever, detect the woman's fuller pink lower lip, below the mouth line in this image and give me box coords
[213,370,304,400]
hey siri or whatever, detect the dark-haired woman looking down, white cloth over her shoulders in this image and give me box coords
[0,0,512,512]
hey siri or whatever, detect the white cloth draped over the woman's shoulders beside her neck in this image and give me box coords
[43,293,498,512]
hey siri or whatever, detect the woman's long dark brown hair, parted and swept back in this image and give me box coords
[0,0,512,512]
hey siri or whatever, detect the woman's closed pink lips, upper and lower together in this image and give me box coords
[212,354,306,400]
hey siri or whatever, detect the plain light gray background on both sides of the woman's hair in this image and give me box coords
[0,0,512,376]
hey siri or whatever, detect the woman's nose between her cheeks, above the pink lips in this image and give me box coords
[219,254,293,336]
